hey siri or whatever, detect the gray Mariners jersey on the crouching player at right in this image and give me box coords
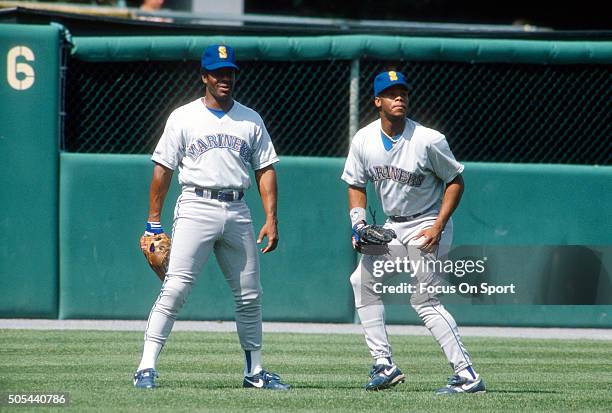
[342,119,464,216]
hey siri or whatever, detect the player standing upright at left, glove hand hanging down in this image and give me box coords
[134,45,289,390]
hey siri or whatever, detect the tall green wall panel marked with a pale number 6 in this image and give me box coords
[0,25,60,317]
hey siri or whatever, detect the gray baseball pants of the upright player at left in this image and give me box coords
[145,191,262,350]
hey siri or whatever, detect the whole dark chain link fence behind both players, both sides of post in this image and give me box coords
[63,58,612,165]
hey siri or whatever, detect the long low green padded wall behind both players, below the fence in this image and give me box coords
[59,154,612,327]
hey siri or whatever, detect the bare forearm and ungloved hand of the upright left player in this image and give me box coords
[255,165,278,254]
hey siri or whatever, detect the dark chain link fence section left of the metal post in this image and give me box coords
[64,60,350,156]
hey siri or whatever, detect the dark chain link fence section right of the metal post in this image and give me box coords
[359,61,612,165]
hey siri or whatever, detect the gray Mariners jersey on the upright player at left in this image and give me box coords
[151,98,278,190]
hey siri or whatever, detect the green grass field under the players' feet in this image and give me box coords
[0,330,612,413]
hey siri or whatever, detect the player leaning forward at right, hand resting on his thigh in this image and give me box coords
[342,71,485,394]
